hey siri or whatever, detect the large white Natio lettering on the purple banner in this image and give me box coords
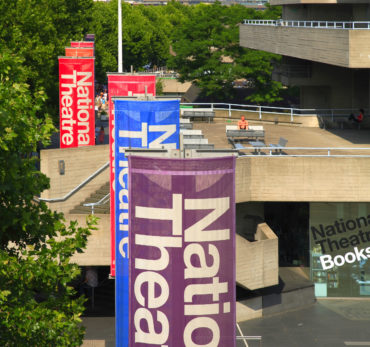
[183,197,230,347]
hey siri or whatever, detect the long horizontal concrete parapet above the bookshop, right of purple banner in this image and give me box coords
[236,156,370,203]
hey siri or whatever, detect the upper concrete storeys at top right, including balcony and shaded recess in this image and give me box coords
[240,0,370,110]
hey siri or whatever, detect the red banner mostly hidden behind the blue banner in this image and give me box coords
[107,73,155,276]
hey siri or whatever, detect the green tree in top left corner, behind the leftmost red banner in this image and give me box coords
[0,0,93,119]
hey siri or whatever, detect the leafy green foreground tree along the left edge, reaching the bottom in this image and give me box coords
[0,48,94,346]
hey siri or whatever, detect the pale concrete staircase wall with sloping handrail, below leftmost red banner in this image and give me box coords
[41,145,109,213]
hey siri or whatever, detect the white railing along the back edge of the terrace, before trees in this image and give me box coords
[181,102,360,122]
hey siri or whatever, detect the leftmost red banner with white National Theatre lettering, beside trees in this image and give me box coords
[59,57,95,148]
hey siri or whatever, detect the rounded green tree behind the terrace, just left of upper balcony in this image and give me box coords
[169,4,235,97]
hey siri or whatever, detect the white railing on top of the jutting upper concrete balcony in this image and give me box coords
[243,19,370,30]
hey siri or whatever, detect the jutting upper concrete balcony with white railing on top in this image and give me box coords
[240,20,370,68]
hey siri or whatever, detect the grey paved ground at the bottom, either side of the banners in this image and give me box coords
[83,299,370,347]
